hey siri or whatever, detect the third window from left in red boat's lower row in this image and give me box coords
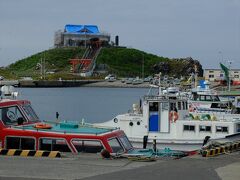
[72,139,104,153]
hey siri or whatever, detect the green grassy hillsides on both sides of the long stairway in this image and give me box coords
[0,47,201,79]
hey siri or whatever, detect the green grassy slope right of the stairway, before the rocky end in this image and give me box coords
[97,48,170,77]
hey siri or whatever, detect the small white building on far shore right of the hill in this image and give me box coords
[204,69,240,81]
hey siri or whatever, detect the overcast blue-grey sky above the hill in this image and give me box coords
[0,0,240,68]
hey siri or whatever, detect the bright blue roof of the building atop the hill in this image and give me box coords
[65,24,100,34]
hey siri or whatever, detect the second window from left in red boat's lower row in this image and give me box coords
[39,138,71,152]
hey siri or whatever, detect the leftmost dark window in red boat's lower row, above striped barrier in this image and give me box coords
[6,137,35,150]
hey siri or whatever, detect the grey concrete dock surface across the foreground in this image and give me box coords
[0,152,240,180]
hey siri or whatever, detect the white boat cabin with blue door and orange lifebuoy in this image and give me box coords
[143,94,188,133]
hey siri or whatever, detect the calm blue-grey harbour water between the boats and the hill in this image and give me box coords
[17,87,148,122]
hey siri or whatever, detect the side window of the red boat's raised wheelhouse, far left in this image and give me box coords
[0,106,26,125]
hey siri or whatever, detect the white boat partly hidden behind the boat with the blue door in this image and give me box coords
[188,80,240,124]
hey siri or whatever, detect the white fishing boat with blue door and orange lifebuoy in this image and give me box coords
[97,85,240,151]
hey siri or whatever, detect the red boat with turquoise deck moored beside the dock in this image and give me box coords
[0,87,133,154]
